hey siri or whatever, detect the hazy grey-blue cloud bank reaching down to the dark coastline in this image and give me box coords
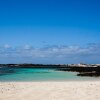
[0,43,100,64]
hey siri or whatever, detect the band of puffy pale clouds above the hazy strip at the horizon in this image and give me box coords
[0,44,100,62]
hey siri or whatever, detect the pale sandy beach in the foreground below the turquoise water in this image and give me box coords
[0,81,100,100]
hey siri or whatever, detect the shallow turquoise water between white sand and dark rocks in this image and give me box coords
[0,68,99,82]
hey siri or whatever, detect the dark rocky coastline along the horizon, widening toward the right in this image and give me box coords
[0,64,100,77]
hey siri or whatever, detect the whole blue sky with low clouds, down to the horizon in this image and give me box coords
[0,0,100,64]
